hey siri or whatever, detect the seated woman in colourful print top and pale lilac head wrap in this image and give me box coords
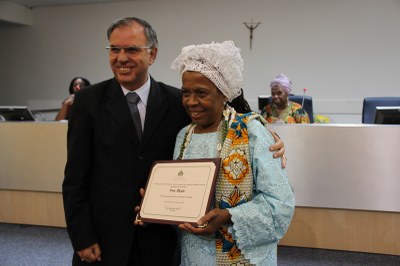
[261,74,310,124]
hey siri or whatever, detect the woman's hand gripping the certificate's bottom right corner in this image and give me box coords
[179,208,232,235]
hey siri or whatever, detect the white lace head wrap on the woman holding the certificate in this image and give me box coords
[171,41,243,102]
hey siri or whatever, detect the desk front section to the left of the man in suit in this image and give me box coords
[0,122,67,227]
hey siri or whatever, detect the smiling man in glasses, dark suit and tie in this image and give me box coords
[63,18,283,266]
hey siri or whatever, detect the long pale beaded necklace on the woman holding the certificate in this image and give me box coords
[178,105,236,160]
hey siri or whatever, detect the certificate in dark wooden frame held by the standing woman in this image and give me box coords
[137,158,221,225]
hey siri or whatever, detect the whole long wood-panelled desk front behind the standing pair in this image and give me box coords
[0,122,400,255]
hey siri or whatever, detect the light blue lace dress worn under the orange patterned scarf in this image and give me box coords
[174,120,295,266]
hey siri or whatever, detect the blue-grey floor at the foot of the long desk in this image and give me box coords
[0,223,400,266]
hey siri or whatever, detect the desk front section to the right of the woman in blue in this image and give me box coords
[269,124,400,255]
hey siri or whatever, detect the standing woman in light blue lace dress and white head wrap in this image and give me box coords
[172,41,294,266]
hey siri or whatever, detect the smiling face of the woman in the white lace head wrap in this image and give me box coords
[182,71,227,133]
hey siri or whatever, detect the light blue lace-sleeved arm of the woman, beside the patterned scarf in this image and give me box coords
[228,121,295,263]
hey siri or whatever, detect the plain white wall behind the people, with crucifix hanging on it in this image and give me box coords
[0,0,400,123]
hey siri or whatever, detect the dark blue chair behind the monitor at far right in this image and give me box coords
[362,97,400,124]
